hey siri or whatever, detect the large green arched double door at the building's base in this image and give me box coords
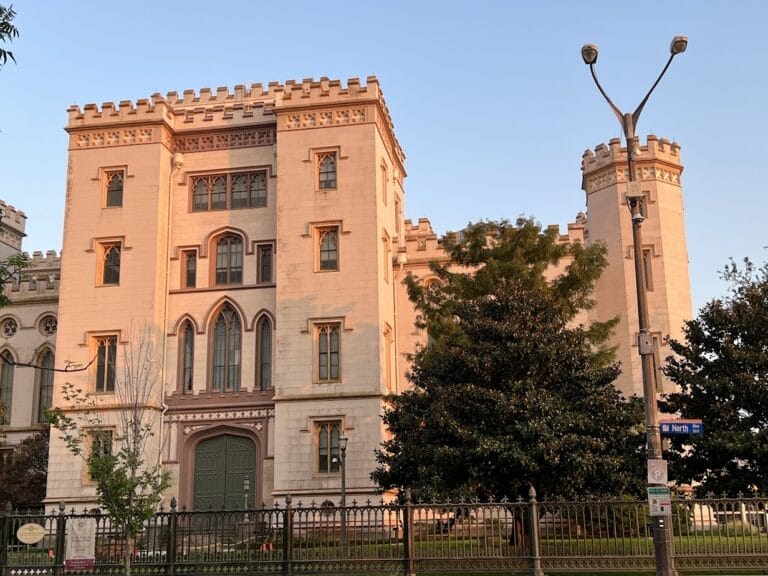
[193,434,256,510]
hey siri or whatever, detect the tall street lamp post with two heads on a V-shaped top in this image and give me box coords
[581,36,688,576]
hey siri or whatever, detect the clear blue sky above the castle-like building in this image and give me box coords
[0,0,768,308]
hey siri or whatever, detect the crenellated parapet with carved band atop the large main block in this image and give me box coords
[67,76,405,167]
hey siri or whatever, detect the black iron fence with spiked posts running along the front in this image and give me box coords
[0,493,768,576]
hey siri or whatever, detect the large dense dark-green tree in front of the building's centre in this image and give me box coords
[372,219,644,499]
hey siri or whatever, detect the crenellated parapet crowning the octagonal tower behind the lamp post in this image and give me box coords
[581,135,683,194]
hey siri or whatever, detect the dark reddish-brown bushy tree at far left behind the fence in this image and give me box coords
[0,430,48,510]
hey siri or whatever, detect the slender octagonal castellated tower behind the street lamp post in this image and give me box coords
[581,136,692,396]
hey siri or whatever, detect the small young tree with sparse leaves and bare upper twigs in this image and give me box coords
[49,329,170,576]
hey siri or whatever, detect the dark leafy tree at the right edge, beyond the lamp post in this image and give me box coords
[662,259,768,496]
